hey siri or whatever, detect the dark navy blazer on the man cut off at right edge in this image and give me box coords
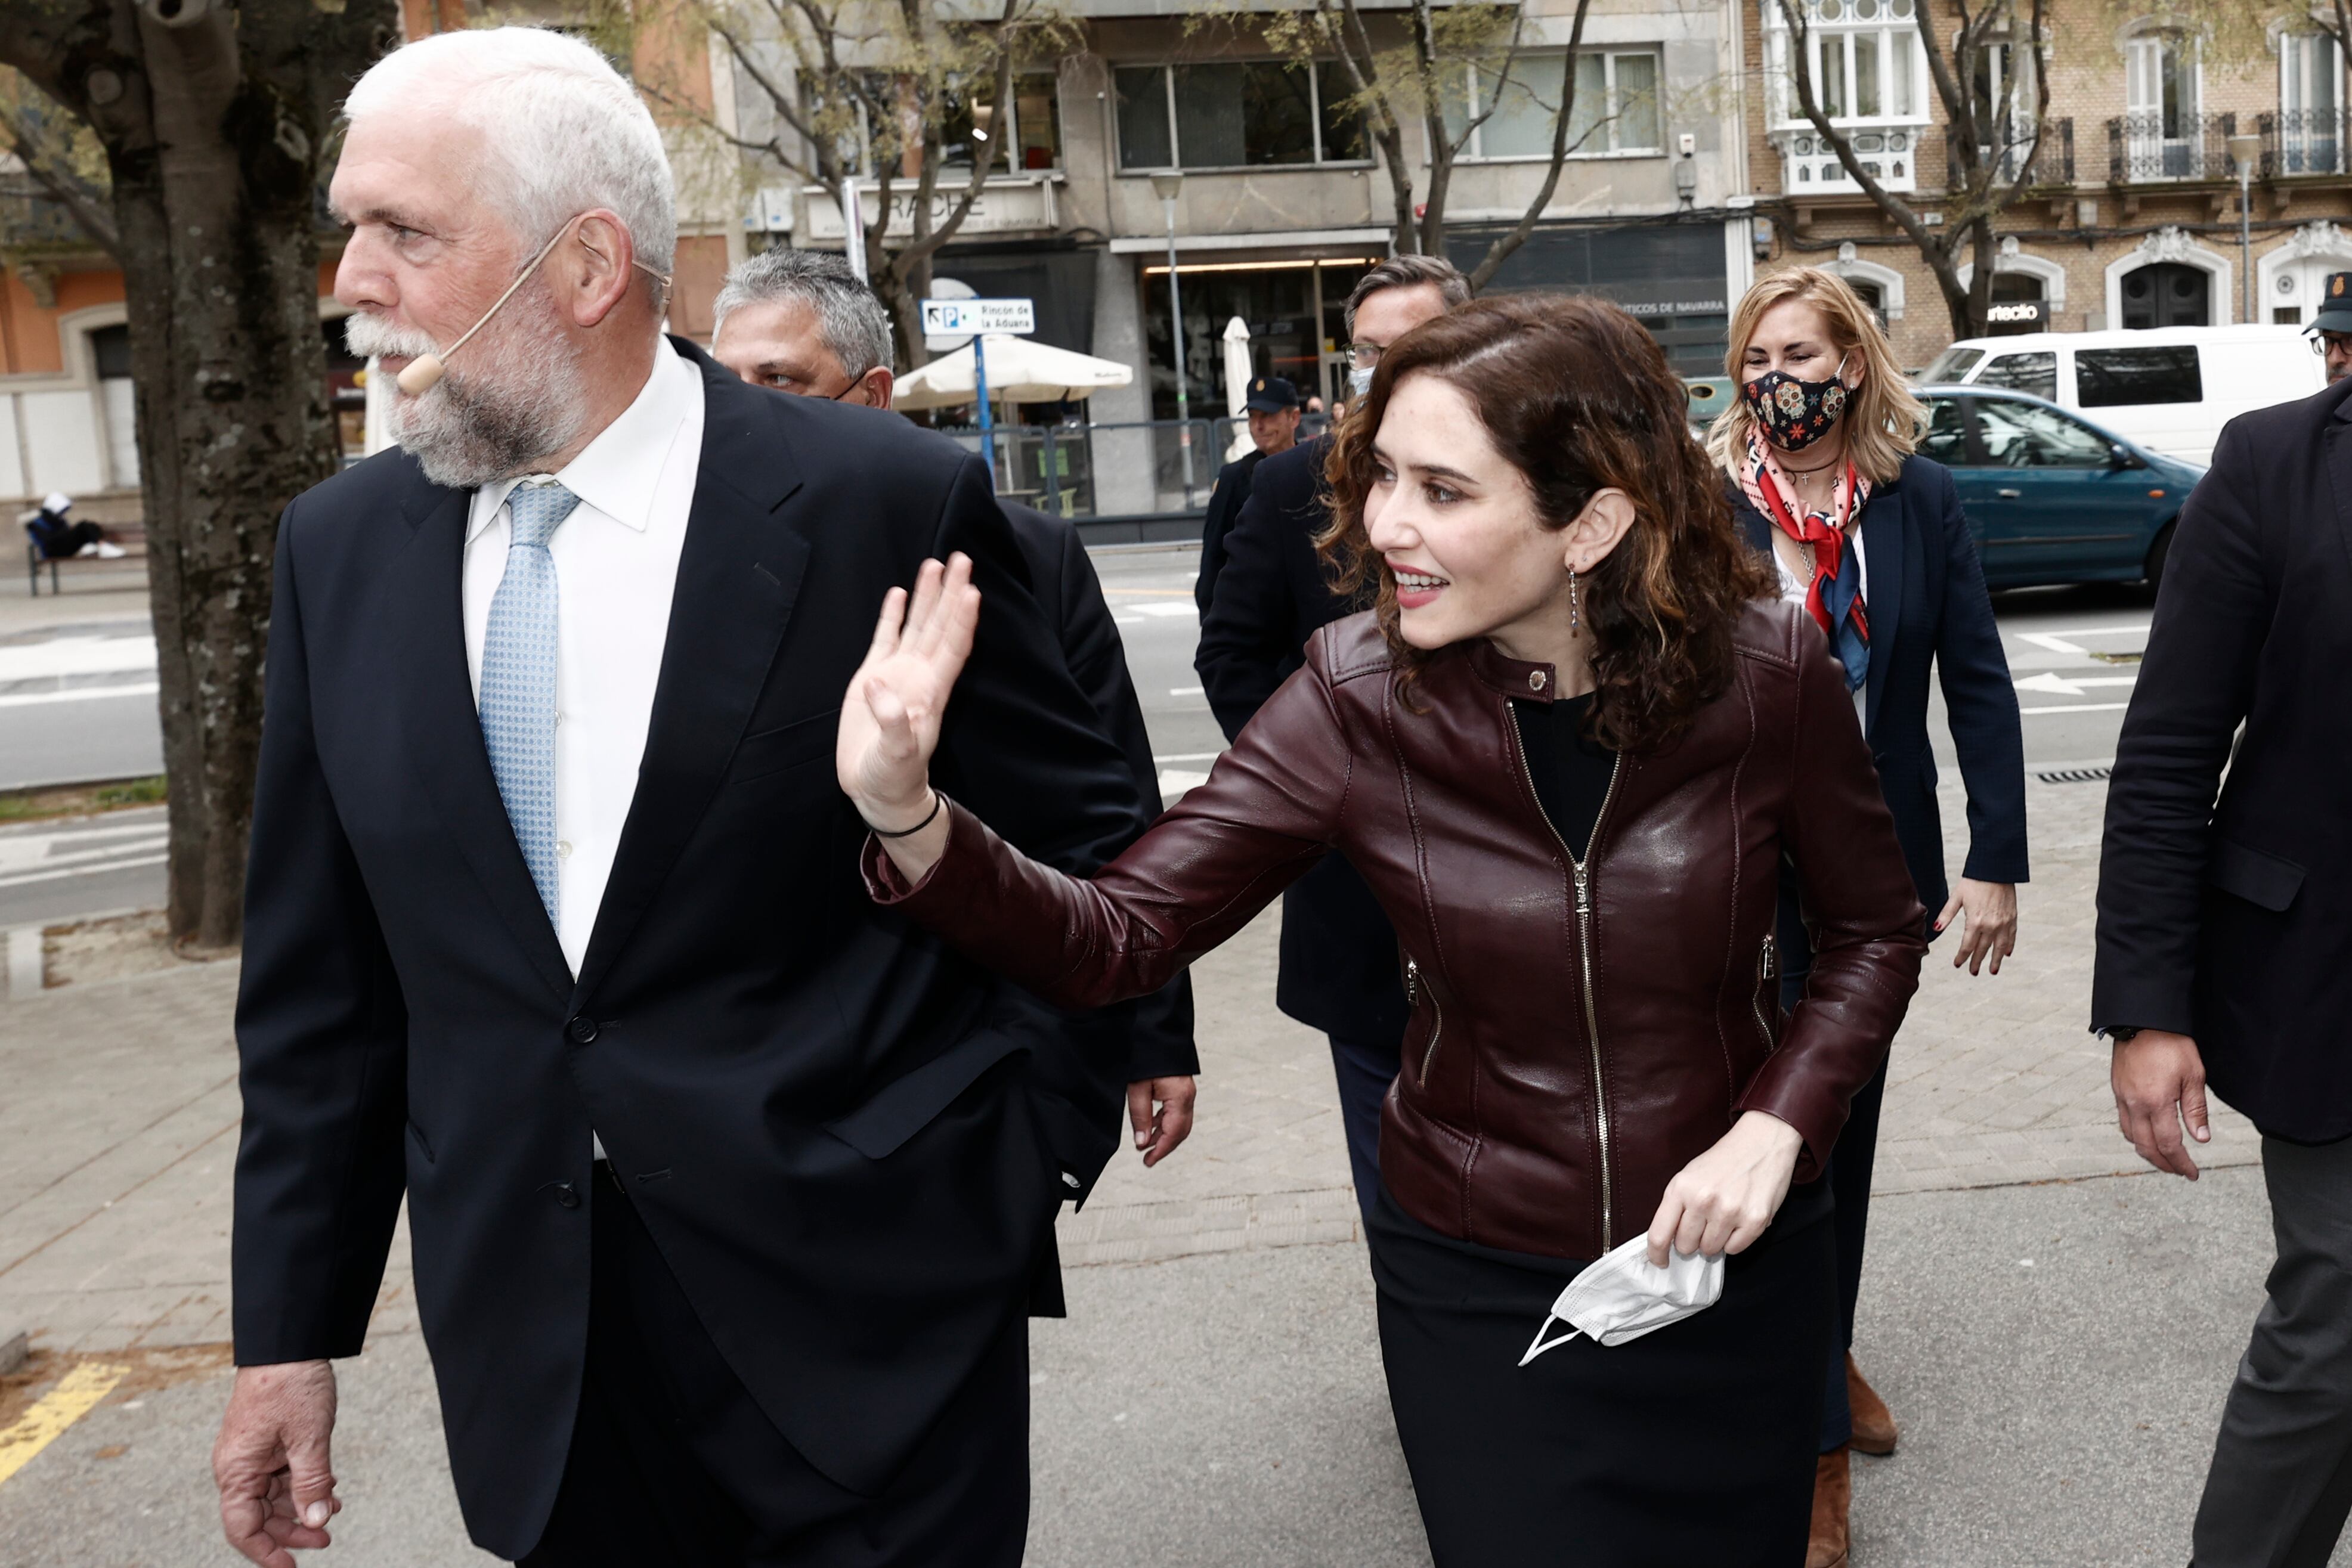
[2091,381,2352,1142]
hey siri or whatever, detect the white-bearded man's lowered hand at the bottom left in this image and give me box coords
[212,1361,343,1568]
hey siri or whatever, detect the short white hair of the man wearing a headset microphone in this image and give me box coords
[343,28,677,291]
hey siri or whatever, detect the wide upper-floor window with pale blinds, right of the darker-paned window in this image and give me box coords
[1447,49,1665,157]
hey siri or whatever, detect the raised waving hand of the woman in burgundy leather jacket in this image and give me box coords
[833,553,981,877]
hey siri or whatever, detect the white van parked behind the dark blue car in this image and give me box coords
[1919,327,2329,463]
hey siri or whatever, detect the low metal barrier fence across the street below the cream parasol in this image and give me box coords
[941,414,1326,522]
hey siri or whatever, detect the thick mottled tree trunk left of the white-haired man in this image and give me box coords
[0,0,400,947]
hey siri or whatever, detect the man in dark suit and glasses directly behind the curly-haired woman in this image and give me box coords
[1193,256,1470,1216]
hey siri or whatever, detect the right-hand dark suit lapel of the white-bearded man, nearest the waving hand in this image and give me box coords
[574,352,809,999]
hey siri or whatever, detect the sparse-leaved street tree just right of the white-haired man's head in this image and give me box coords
[640,0,1079,369]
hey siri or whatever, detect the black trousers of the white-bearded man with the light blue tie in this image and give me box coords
[522,1164,1028,1568]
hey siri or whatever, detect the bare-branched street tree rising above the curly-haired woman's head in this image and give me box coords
[1230,0,1599,292]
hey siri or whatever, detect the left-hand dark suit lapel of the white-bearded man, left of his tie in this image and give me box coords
[386,484,571,997]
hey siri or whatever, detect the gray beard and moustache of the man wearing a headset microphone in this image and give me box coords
[343,287,588,489]
